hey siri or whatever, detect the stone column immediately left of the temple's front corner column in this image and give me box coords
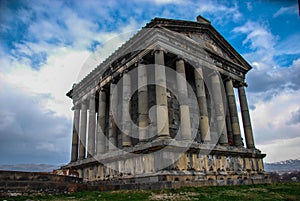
[137,64,149,142]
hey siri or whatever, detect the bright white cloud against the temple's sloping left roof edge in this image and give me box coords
[0,5,138,119]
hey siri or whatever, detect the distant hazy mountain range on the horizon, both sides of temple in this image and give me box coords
[0,159,300,172]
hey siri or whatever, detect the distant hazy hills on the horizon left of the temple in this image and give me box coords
[0,164,60,172]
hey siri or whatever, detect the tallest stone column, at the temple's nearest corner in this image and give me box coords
[154,50,170,137]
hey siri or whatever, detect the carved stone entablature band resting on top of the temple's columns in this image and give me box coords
[67,22,248,101]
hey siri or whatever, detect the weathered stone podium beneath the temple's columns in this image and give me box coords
[63,139,268,188]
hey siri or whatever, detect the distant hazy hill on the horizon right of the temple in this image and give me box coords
[265,159,300,172]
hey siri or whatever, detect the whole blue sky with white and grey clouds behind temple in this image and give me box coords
[0,0,300,165]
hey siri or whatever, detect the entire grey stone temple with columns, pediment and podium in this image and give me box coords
[62,16,268,188]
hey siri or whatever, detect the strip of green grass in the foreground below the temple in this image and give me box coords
[0,182,300,201]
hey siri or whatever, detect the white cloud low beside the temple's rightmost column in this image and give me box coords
[248,90,300,143]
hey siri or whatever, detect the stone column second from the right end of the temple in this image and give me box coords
[225,79,242,146]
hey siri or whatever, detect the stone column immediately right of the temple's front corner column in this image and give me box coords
[176,59,192,140]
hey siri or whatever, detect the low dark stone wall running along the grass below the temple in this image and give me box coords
[0,170,270,197]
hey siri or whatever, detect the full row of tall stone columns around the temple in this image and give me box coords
[71,50,255,162]
